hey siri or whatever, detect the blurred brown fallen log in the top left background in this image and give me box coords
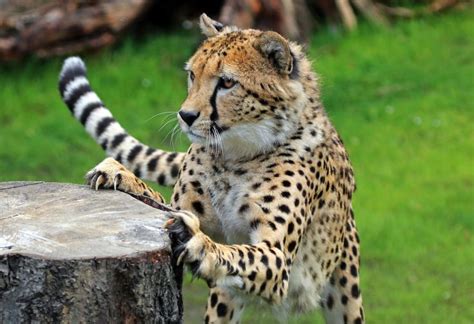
[0,0,152,59]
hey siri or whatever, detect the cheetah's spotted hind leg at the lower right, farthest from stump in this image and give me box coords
[321,239,364,324]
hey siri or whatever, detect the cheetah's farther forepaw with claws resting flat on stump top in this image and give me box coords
[86,158,165,203]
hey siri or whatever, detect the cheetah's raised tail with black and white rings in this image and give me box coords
[59,57,184,185]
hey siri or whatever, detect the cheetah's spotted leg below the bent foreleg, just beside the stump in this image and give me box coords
[204,287,244,324]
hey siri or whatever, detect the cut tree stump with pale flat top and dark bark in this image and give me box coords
[0,182,182,323]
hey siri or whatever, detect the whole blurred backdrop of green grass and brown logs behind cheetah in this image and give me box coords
[0,0,474,323]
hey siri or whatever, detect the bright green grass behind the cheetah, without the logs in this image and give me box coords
[0,9,474,323]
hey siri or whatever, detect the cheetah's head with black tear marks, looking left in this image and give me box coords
[178,15,304,160]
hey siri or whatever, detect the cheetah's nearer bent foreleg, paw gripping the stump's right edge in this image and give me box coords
[165,211,298,308]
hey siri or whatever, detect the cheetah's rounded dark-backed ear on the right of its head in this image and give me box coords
[254,31,293,75]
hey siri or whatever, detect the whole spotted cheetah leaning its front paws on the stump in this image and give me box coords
[59,14,364,323]
